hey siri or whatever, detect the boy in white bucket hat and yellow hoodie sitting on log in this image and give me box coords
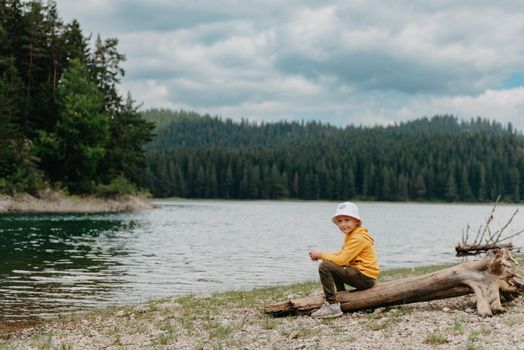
[309,202,379,318]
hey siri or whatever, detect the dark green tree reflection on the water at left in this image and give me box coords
[0,214,136,320]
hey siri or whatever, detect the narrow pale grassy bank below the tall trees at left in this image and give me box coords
[0,189,155,213]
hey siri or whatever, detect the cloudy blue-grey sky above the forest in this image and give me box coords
[58,0,524,130]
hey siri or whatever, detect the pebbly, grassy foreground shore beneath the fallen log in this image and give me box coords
[4,256,524,350]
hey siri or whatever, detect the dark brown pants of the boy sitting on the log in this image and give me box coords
[318,261,375,304]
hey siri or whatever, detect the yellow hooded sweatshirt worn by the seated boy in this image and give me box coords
[320,226,380,278]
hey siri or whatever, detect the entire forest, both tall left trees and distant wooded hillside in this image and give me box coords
[0,0,524,202]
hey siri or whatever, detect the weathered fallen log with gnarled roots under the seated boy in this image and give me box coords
[264,249,524,317]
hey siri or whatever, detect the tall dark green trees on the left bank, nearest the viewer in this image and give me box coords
[0,0,153,193]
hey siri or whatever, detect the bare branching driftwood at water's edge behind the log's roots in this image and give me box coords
[455,196,524,256]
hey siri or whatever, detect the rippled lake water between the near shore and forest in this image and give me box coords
[0,200,524,321]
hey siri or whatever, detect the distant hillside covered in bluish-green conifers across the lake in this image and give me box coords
[141,110,524,201]
